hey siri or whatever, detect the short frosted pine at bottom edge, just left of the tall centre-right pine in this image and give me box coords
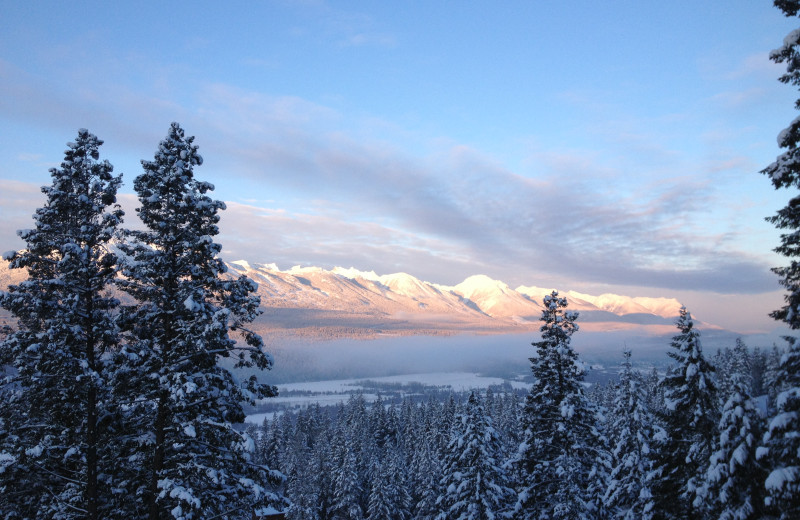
[436,392,514,520]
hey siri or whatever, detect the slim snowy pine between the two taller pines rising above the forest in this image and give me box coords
[604,349,657,520]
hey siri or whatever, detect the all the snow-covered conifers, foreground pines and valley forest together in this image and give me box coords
[0,0,800,520]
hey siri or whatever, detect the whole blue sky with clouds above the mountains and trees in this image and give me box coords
[0,0,798,332]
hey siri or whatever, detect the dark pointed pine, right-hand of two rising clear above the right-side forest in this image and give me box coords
[652,307,718,518]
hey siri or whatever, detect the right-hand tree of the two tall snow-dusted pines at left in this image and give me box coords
[116,123,283,520]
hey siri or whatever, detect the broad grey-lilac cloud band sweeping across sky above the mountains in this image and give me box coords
[0,59,774,293]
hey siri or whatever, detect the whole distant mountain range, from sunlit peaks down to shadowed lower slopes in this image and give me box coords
[0,260,696,339]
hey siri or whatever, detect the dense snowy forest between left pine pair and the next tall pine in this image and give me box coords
[248,389,521,520]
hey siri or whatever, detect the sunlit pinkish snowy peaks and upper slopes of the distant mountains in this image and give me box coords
[222,261,681,327]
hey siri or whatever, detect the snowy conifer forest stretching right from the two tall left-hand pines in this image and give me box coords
[248,292,800,520]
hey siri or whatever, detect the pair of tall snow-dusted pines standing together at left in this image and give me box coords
[0,123,283,520]
